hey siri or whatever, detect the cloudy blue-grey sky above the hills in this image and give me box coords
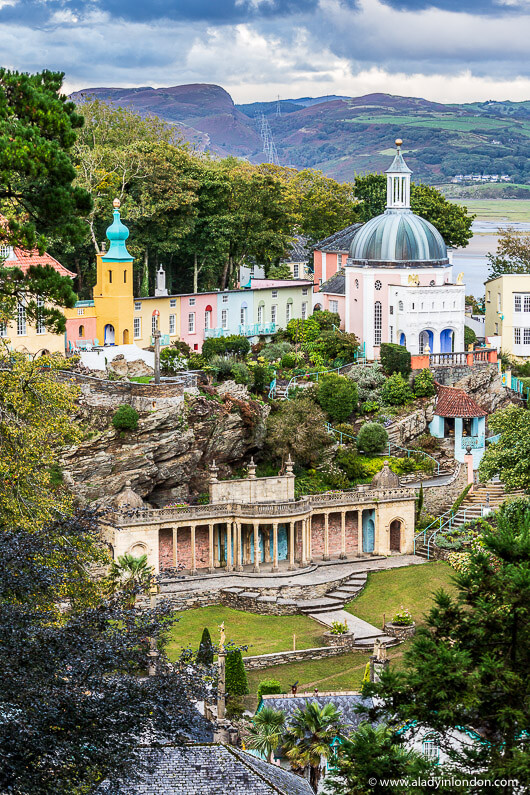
[0,0,530,102]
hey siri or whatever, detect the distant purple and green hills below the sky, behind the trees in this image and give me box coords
[72,84,530,184]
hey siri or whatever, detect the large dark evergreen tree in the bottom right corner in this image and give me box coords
[364,501,530,792]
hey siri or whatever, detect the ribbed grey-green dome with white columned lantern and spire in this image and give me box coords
[350,138,449,267]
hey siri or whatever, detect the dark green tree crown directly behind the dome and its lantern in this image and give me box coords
[354,174,475,246]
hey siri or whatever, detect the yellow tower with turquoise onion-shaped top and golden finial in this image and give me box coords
[94,199,133,345]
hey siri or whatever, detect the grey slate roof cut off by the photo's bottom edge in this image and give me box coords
[105,743,313,795]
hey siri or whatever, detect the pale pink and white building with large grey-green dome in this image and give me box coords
[315,140,465,359]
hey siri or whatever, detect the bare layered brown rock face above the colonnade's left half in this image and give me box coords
[62,396,269,508]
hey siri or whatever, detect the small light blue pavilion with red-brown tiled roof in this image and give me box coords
[429,385,488,469]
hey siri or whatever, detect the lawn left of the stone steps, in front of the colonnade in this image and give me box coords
[167,605,325,659]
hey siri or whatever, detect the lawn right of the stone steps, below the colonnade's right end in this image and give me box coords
[346,561,454,627]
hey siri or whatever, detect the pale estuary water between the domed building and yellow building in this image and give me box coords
[453,219,530,298]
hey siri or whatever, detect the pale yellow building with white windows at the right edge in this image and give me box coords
[485,273,530,359]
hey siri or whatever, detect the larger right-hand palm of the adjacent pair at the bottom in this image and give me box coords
[282,701,342,792]
